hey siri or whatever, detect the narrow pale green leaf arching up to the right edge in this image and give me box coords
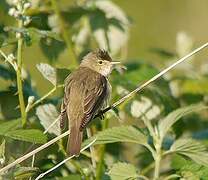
[158,104,208,138]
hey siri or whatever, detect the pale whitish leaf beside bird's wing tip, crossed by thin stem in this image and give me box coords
[36,104,61,136]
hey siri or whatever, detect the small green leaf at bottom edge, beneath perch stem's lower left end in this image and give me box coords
[14,167,39,179]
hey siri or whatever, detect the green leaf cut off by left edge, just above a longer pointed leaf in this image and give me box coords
[0,119,21,135]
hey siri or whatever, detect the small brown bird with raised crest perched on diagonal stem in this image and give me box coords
[61,49,119,156]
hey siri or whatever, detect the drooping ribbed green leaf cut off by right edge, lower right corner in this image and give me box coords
[169,139,208,166]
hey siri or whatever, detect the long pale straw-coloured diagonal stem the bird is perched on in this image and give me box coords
[0,42,208,173]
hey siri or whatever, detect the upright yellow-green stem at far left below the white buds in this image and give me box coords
[16,20,27,127]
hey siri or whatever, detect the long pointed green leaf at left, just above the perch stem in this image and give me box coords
[4,129,47,144]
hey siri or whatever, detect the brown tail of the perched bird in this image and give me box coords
[67,126,83,156]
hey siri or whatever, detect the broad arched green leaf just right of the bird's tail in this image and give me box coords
[83,126,147,147]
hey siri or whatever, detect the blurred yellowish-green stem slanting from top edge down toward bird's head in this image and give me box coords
[51,0,78,67]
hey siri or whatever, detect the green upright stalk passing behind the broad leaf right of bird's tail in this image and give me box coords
[96,119,109,180]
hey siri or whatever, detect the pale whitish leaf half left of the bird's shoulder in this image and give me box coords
[36,63,56,86]
